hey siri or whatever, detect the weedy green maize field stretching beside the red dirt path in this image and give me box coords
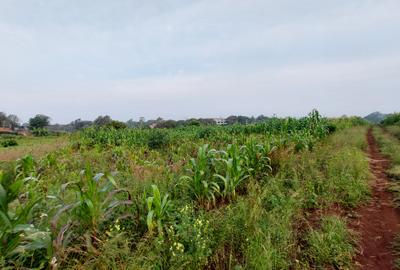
[0,111,400,269]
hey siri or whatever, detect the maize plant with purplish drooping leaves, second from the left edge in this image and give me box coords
[51,166,133,256]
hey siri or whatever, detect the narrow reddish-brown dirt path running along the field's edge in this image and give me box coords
[353,130,400,270]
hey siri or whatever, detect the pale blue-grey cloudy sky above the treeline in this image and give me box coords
[0,0,400,123]
